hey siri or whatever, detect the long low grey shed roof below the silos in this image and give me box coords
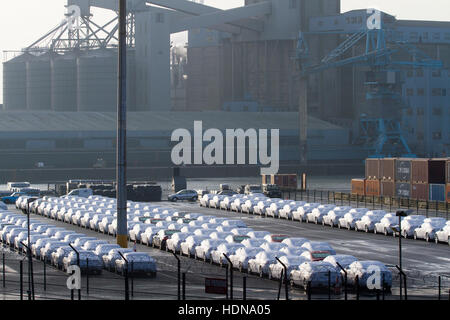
[0,111,342,132]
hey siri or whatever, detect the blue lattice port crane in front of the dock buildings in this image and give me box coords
[296,25,443,159]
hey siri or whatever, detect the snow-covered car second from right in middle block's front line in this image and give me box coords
[291,261,341,289]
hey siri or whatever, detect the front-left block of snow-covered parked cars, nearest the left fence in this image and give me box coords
[0,202,156,276]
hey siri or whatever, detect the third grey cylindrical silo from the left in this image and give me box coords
[51,53,77,111]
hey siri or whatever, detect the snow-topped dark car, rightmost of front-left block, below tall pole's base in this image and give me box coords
[116,252,157,276]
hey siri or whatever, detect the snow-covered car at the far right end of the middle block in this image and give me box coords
[347,261,392,291]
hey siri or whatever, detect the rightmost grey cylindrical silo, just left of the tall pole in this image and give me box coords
[77,49,118,112]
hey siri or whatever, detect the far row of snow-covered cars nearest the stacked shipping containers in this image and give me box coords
[200,194,450,245]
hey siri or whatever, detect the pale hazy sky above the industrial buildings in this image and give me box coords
[0,0,450,103]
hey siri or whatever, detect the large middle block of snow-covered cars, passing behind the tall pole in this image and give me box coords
[17,196,392,289]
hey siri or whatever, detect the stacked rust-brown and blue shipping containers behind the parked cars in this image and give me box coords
[352,158,450,202]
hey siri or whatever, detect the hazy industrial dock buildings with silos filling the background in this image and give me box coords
[0,0,450,175]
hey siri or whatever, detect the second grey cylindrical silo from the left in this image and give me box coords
[27,54,51,111]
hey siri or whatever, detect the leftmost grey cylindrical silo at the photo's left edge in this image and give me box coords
[3,53,31,111]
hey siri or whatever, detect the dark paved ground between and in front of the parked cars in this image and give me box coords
[0,202,450,299]
